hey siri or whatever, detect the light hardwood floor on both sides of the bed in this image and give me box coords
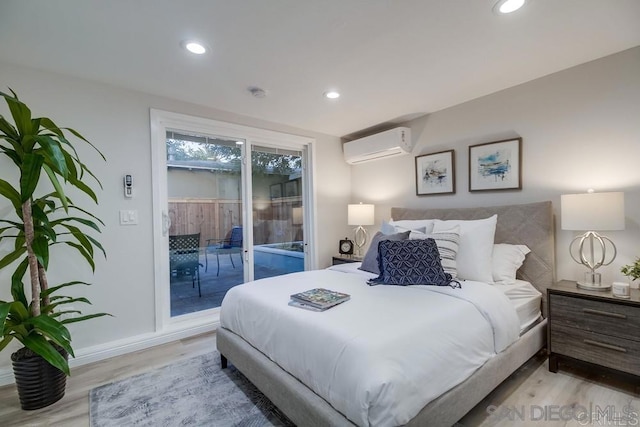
[0,333,640,427]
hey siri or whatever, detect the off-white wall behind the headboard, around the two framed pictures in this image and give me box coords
[352,47,640,288]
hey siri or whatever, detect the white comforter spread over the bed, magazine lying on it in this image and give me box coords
[220,270,519,426]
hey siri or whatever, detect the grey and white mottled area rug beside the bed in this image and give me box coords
[89,351,294,427]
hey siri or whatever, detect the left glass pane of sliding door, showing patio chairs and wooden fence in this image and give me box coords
[166,130,245,317]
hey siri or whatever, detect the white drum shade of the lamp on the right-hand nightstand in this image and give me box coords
[560,192,624,231]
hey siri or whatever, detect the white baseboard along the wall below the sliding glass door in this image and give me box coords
[0,319,220,386]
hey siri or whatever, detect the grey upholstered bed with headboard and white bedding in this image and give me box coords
[217,202,554,426]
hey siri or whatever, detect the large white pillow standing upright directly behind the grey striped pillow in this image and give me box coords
[433,215,498,283]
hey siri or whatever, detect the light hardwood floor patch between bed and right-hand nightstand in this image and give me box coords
[458,352,640,427]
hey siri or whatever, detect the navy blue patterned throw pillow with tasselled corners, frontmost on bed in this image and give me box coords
[368,238,460,288]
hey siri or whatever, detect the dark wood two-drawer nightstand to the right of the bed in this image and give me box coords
[547,280,640,375]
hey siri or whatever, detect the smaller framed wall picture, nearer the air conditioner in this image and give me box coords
[416,150,456,196]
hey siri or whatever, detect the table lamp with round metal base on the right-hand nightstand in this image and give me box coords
[561,190,624,291]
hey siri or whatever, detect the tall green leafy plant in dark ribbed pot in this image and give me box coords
[0,91,107,409]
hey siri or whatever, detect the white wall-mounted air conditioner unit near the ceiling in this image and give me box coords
[343,127,412,165]
